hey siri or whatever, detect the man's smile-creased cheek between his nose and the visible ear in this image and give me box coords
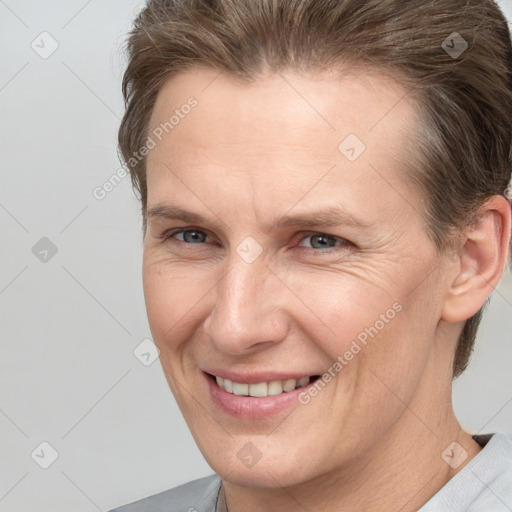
[287,266,436,394]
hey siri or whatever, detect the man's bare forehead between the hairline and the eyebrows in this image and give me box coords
[147,68,417,220]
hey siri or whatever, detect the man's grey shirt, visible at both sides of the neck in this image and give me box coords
[110,432,512,512]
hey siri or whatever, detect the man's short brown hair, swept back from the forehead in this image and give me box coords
[119,0,512,377]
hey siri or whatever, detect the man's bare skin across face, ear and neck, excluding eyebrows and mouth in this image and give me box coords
[143,68,510,512]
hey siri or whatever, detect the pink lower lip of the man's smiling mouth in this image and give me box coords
[203,372,316,419]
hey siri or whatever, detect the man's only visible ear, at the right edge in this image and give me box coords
[441,195,511,322]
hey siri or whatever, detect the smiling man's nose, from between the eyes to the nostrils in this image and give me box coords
[204,253,290,356]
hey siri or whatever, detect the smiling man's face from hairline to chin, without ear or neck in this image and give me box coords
[143,69,450,487]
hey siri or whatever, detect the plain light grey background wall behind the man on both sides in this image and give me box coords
[0,0,512,512]
